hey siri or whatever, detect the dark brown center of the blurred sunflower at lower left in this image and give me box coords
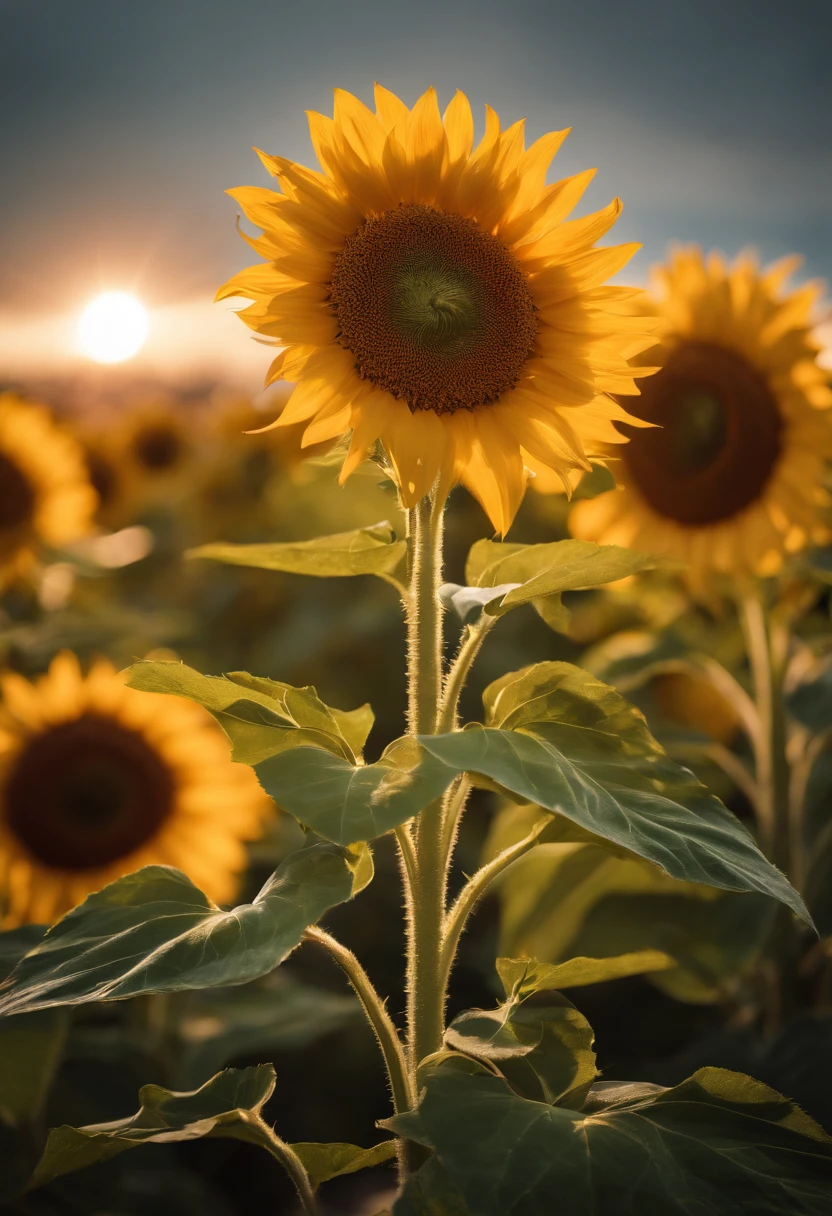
[4,714,175,869]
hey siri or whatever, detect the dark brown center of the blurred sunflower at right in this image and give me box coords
[622,342,782,528]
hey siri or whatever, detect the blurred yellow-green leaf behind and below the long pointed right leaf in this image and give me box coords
[485,806,777,1002]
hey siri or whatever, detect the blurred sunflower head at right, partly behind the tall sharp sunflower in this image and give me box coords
[570,248,832,582]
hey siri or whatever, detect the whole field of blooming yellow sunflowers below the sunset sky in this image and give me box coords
[0,38,832,1216]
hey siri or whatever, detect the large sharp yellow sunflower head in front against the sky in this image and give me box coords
[218,86,652,533]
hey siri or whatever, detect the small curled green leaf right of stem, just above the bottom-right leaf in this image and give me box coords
[445,959,596,1107]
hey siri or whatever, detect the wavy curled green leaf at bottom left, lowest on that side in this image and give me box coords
[29,1064,275,1189]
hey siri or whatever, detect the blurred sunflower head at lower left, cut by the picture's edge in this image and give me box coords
[0,652,271,925]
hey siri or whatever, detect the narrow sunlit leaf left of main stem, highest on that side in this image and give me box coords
[186,520,407,587]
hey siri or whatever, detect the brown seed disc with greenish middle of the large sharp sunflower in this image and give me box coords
[331,204,538,413]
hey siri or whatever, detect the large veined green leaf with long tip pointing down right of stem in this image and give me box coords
[420,663,811,923]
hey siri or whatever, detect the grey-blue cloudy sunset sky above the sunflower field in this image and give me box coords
[0,0,832,377]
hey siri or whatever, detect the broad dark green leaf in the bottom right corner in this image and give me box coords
[387,1065,832,1216]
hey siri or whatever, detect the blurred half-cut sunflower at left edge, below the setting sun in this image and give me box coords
[0,393,96,585]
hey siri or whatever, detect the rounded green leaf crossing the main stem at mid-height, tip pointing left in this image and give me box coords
[254,737,454,844]
